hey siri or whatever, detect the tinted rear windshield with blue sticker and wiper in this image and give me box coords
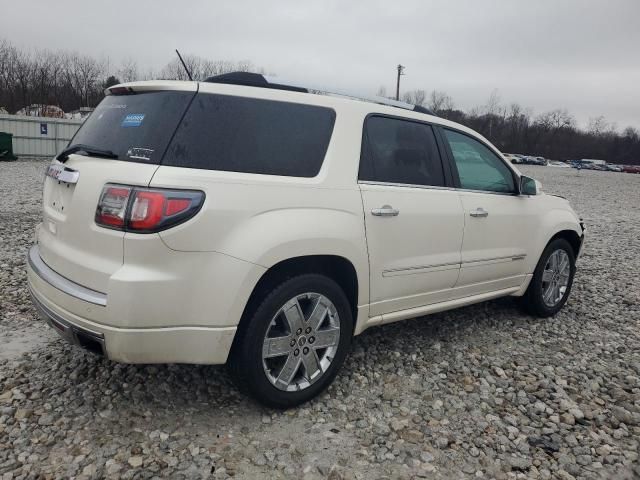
[69,91,194,163]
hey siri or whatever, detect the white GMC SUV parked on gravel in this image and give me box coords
[28,74,584,407]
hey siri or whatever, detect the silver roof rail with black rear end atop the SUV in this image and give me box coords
[205,72,434,115]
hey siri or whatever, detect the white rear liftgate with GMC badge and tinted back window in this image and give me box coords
[38,84,196,292]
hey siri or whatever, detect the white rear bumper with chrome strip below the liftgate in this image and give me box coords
[27,246,236,364]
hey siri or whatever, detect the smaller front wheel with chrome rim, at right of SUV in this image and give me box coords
[522,238,576,317]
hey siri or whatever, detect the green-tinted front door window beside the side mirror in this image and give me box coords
[444,128,515,193]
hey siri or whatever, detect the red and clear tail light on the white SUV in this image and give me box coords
[95,184,204,233]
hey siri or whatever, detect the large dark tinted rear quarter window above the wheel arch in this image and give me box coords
[163,93,335,177]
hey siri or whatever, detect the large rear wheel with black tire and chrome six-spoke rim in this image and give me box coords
[229,274,353,408]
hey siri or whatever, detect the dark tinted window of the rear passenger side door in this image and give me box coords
[358,116,444,186]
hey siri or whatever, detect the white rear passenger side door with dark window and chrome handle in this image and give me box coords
[359,112,464,316]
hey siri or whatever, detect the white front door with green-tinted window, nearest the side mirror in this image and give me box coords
[442,128,537,295]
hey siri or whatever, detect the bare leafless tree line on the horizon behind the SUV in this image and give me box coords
[0,39,640,164]
